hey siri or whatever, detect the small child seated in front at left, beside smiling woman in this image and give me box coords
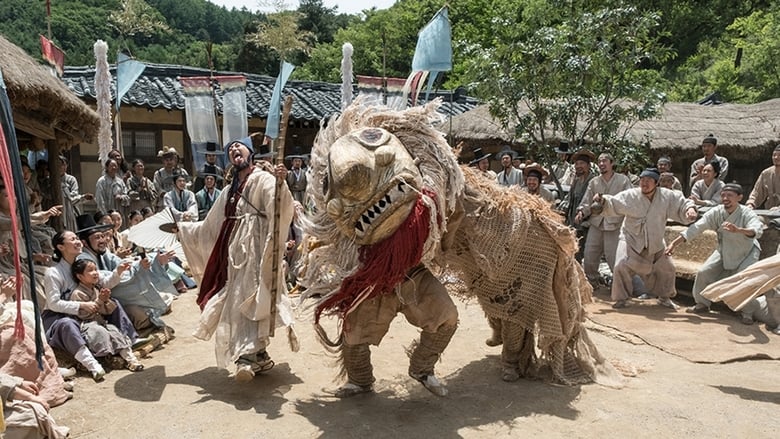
[70,259,144,379]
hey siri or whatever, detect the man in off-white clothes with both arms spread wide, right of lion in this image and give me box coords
[593,168,698,309]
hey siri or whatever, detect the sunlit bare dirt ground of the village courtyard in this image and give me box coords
[52,292,780,439]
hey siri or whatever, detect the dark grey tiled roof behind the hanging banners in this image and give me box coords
[62,63,478,121]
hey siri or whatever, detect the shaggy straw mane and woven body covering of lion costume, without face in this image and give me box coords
[299,99,620,385]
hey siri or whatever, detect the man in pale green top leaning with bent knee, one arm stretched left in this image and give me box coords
[666,183,764,314]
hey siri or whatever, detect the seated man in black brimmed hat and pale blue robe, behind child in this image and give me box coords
[76,215,178,335]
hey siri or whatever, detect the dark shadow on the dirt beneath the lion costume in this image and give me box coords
[296,356,580,438]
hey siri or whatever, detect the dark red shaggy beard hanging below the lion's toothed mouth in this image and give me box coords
[314,191,435,323]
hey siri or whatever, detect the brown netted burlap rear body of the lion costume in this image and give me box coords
[446,167,610,384]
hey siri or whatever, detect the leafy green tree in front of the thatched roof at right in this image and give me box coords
[468,0,673,169]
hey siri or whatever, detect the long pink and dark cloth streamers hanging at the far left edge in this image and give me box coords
[0,70,43,370]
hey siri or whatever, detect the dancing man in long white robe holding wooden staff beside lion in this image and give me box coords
[178,137,297,381]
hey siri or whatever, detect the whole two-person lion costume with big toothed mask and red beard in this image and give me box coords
[300,101,616,397]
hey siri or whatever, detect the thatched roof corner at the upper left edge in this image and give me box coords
[0,36,100,147]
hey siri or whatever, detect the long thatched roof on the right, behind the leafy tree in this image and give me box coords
[452,99,780,153]
